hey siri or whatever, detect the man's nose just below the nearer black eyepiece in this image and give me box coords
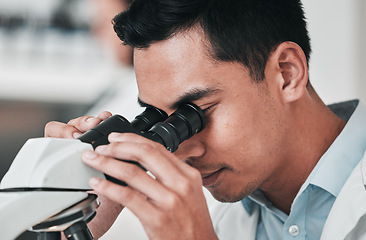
[174,136,205,161]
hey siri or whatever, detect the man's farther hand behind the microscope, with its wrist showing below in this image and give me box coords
[45,112,123,239]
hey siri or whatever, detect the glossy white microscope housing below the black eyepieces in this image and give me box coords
[0,138,105,240]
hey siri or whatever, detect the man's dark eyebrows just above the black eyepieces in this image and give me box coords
[137,88,221,110]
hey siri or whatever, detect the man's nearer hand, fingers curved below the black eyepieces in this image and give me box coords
[83,133,217,240]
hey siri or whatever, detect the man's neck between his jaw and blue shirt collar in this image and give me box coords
[260,94,346,214]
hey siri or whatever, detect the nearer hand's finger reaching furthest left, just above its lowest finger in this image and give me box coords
[82,151,168,202]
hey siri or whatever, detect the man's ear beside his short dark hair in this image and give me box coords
[267,42,308,102]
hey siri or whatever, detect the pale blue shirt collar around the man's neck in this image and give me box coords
[242,100,366,214]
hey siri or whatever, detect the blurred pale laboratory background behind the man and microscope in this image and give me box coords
[0,0,366,239]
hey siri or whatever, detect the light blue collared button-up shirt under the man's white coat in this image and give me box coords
[242,100,366,240]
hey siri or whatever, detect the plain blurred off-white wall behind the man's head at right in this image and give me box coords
[303,0,366,103]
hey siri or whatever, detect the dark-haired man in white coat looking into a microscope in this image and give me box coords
[46,0,366,239]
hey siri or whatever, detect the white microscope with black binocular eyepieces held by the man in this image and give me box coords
[0,103,205,240]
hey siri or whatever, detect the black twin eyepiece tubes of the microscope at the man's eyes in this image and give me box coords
[78,103,205,152]
